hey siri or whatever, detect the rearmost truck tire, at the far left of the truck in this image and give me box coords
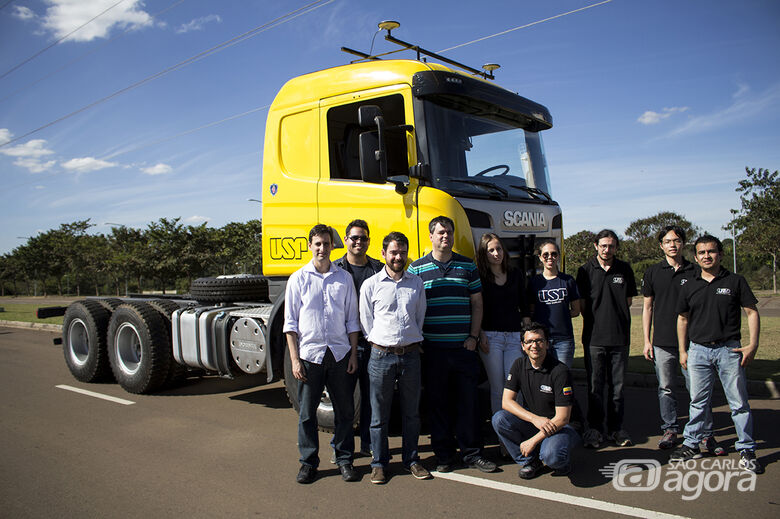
[62,299,111,382]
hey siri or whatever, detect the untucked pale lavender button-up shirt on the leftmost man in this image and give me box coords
[283,262,360,364]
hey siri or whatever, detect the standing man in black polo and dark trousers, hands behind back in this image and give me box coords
[577,229,637,448]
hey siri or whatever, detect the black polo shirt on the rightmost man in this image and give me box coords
[677,267,758,344]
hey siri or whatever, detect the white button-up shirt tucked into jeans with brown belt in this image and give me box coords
[360,268,427,346]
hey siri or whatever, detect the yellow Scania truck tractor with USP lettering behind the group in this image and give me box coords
[49,27,563,428]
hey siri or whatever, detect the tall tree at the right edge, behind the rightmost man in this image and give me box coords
[724,167,780,294]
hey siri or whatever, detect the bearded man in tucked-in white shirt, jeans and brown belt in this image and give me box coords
[360,232,431,484]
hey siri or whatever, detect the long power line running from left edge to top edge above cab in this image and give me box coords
[0,0,335,148]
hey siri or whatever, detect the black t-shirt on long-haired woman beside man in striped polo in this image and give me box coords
[482,269,525,332]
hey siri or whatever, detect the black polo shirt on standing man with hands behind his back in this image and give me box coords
[577,256,637,346]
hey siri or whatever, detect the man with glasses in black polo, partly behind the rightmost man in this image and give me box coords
[642,225,726,456]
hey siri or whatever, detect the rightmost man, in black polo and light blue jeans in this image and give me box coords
[669,235,764,474]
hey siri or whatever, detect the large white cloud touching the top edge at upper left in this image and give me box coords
[43,0,152,41]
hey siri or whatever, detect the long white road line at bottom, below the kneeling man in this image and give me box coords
[433,472,685,519]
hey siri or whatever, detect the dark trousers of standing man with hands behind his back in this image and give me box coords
[585,345,628,434]
